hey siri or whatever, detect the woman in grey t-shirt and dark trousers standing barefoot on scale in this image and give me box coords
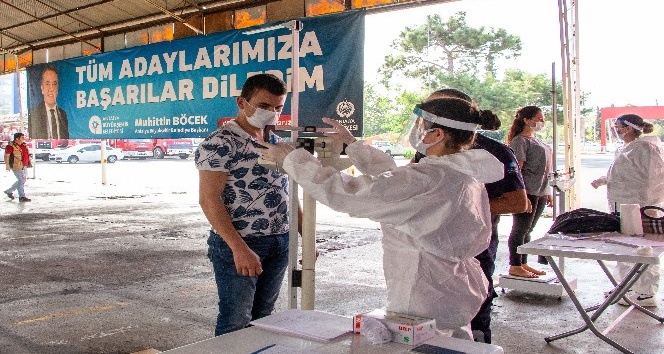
[507,106,553,278]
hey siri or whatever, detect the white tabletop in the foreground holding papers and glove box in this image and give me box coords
[164,318,503,354]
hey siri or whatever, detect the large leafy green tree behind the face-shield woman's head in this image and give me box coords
[365,12,592,145]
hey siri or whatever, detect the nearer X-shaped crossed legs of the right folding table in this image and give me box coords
[544,256,642,354]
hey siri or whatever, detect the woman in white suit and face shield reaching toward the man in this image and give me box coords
[263,98,503,339]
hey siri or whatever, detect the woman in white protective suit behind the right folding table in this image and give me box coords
[592,114,664,306]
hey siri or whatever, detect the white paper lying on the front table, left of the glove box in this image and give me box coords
[251,309,353,342]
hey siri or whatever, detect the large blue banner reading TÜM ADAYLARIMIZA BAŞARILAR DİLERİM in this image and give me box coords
[27,11,364,139]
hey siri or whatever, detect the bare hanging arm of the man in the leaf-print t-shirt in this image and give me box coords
[198,170,263,276]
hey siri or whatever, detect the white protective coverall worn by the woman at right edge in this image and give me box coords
[606,138,664,295]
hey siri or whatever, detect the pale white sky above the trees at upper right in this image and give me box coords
[364,0,664,107]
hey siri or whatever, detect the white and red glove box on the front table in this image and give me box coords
[353,309,436,345]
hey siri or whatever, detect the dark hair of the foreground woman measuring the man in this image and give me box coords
[419,97,493,150]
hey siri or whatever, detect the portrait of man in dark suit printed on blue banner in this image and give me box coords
[28,65,69,139]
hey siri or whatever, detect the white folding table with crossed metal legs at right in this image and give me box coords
[517,235,664,353]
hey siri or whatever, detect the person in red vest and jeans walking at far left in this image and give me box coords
[5,133,32,202]
